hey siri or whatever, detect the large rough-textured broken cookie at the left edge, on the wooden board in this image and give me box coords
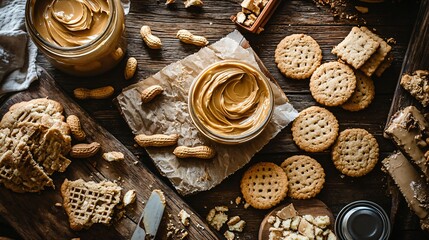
[0,98,71,192]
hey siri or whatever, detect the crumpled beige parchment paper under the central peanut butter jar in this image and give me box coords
[117,31,298,195]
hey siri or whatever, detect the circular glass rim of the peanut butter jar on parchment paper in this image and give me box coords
[188,59,274,145]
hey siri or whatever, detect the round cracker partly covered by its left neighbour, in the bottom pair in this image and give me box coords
[281,155,325,199]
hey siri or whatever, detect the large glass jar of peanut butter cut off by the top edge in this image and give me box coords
[25,0,127,76]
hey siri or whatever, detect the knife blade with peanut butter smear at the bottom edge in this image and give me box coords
[131,189,165,240]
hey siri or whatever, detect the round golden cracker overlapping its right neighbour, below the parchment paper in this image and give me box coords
[240,162,288,209]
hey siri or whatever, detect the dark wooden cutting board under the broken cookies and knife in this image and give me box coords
[0,72,218,239]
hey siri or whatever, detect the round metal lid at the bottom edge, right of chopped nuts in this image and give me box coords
[335,200,391,240]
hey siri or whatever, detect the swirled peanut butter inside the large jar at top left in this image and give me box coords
[32,0,110,47]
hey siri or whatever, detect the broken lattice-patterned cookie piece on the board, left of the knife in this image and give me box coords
[61,179,122,230]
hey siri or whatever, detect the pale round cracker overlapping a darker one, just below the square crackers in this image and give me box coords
[310,62,356,107]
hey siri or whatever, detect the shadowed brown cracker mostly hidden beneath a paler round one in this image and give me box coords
[341,71,375,112]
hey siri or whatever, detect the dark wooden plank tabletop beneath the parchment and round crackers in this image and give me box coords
[0,0,429,239]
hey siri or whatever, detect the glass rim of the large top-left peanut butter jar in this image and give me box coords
[25,0,116,52]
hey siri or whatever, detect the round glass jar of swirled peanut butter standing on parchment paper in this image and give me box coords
[188,60,274,144]
